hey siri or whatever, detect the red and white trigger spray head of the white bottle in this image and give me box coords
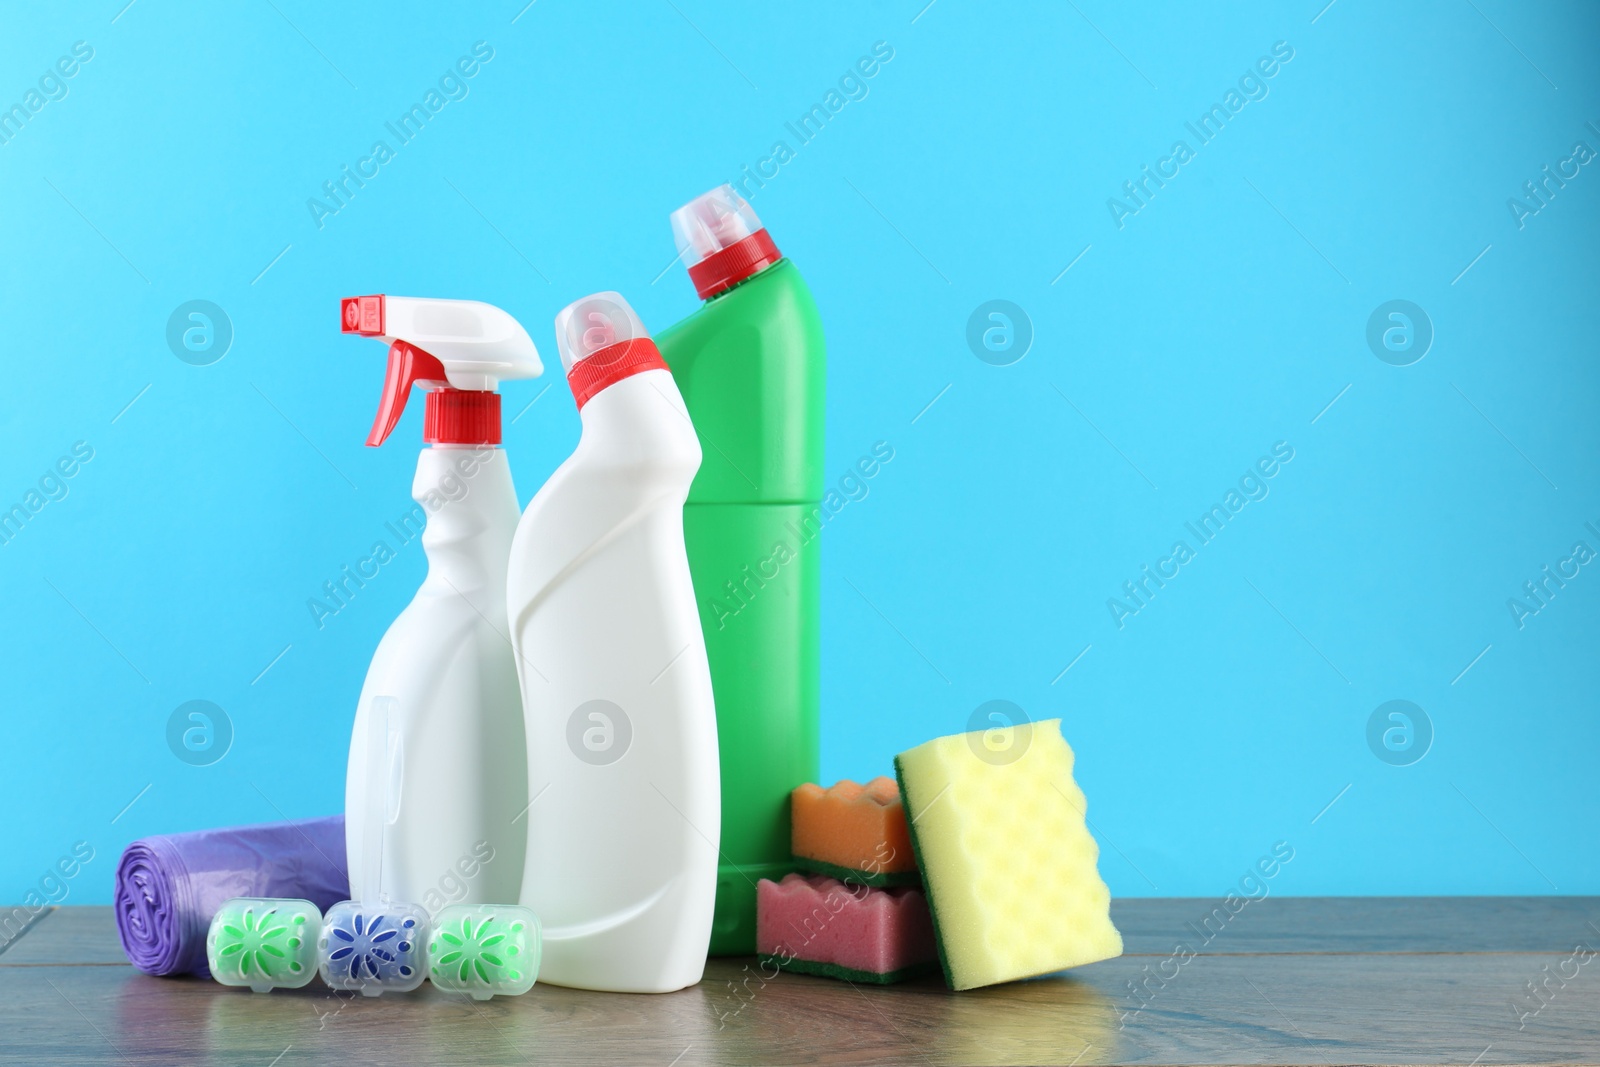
[339,294,544,446]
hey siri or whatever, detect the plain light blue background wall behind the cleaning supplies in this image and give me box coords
[0,0,1600,904]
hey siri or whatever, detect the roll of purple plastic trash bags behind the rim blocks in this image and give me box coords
[114,816,350,974]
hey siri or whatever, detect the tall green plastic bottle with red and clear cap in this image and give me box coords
[656,186,827,955]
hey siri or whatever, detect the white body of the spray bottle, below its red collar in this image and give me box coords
[344,446,528,912]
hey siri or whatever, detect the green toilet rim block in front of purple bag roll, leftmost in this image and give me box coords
[205,897,322,993]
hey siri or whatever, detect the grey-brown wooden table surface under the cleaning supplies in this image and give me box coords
[0,897,1600,1067]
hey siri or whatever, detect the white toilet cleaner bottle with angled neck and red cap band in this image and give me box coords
[506,293,722,993]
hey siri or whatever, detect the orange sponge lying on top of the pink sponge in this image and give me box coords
[790,777,918,886]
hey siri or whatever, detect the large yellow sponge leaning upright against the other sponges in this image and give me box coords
[894,718,1122,989]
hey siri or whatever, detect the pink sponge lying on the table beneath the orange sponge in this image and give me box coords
[755,875,938,985]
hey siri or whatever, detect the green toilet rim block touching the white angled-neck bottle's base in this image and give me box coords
[427,904,542,1000]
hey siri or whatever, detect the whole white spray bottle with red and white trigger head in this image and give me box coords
[341,296,544,912]
